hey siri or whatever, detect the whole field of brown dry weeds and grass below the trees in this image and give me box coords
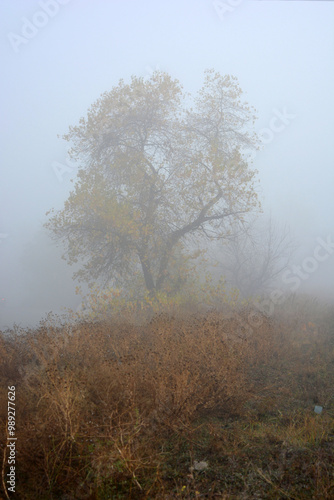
[0,294,334,500]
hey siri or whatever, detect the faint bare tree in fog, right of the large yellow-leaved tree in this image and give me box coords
[217,218,295,298]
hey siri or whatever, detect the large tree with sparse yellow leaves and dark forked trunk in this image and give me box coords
[46,70,258,295]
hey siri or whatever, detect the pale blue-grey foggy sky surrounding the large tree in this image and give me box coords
[0,0,334,328]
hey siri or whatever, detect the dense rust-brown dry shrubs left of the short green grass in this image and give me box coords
[0,308,253,498]
